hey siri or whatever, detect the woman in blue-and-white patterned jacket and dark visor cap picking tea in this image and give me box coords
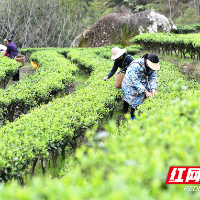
[122,53,160,119]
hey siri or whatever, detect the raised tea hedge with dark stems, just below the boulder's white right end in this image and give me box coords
[130,33,200,60]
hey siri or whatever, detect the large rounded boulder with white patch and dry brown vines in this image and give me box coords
[71,10,177,47]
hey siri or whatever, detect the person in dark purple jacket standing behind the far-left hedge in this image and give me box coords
[4,38,19,81]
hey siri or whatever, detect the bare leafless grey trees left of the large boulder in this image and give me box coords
[0,0,85,48]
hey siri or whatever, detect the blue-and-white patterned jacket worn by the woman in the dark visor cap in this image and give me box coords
[121,58,157,108]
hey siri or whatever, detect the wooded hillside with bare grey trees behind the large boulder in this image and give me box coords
[0,0,199,48]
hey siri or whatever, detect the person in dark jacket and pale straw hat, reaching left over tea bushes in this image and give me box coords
[103,47,134,113]
